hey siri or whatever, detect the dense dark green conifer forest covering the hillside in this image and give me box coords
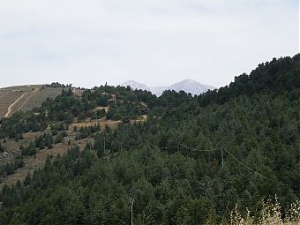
[0,54,300,224]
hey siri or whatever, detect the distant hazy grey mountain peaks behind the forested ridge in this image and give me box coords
[121,79,215,96]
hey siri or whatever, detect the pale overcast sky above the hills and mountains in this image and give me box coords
[0,0,300,88]
